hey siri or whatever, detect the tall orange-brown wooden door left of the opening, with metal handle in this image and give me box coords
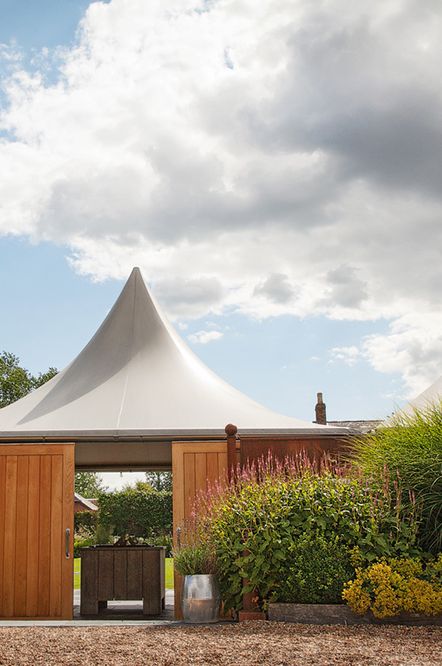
[0,444,74,619]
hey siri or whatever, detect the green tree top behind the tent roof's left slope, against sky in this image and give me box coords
[0,351,57,408]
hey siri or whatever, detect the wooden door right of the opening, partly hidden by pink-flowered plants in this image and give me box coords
[172,441,227,619]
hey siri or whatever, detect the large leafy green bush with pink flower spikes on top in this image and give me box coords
[196,465,417,609]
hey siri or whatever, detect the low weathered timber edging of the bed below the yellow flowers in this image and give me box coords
[268,603,442,626]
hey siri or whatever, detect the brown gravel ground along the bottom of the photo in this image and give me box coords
[0,622,442,666]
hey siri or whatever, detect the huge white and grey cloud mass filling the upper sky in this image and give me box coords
[0,0,442,387]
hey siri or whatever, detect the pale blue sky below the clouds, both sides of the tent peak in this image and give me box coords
[0,238,400,420]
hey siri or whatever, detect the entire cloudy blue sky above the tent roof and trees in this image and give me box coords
[0,0,442,482]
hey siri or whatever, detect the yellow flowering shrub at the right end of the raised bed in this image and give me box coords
[342,554,442,618]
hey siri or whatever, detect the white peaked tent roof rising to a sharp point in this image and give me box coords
[0,268,346,441]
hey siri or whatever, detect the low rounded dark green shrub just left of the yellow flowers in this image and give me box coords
[275,532,354,604]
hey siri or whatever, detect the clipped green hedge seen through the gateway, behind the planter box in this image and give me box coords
[98,483,172,540]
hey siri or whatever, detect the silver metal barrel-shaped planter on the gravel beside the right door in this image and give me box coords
[181,574,220,624]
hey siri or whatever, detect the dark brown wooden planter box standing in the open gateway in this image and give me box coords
[80,546,166,615]
